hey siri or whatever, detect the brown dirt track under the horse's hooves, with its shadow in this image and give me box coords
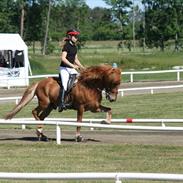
[0,129,183,146]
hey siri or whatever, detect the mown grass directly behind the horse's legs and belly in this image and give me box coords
[0,92,183,118]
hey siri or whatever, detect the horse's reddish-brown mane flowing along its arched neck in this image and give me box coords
[78,64,112,83]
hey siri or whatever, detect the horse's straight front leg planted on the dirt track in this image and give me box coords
[76,106,84,142]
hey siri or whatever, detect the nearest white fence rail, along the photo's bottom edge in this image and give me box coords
[0,172,183,183]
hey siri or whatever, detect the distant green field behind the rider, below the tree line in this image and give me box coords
[29,41,183,82]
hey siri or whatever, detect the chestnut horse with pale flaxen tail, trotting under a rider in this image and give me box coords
[5,65,121,141]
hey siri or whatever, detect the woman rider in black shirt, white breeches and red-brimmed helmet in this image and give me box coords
[58,29,84,112]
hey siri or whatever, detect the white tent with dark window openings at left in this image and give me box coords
[0,33,30,88]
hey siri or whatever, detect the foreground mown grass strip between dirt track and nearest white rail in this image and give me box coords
[0,143,183,183]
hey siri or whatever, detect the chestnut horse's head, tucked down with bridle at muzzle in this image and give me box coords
[103,68,121,102]
